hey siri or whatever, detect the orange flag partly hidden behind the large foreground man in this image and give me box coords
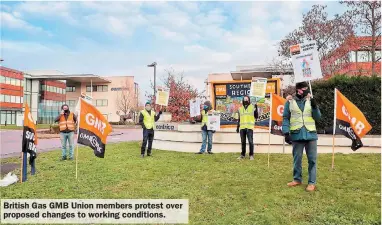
[270,94,286,136]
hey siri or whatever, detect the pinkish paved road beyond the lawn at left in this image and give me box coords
[0,129,142,158]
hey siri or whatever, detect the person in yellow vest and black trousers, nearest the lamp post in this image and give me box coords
[139,102,162,158]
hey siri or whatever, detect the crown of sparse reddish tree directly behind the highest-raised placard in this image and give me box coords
[278,5,354,73]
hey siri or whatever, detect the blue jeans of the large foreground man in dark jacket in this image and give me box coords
[293,141,317,184]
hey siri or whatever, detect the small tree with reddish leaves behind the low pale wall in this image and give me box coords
[146,69,202,122]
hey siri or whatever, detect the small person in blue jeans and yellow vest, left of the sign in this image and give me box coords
[196,101,215,154]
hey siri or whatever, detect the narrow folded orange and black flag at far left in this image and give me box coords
[22,103,37,165]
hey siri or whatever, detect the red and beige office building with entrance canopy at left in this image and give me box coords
[0,67,139,125]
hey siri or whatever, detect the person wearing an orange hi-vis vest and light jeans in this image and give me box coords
[55,104,77,160]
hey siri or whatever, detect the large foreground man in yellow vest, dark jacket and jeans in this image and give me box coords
[282,82,321,192]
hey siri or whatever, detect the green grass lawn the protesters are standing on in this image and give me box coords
[1,142,381,225]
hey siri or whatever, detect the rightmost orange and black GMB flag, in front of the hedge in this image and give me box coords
[334,89,372,151]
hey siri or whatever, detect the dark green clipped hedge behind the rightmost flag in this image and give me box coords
[285,75,381,135]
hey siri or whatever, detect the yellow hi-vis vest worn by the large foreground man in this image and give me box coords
[289,99,316,131]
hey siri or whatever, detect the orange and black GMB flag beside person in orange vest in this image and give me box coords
[77,98,112,158]
